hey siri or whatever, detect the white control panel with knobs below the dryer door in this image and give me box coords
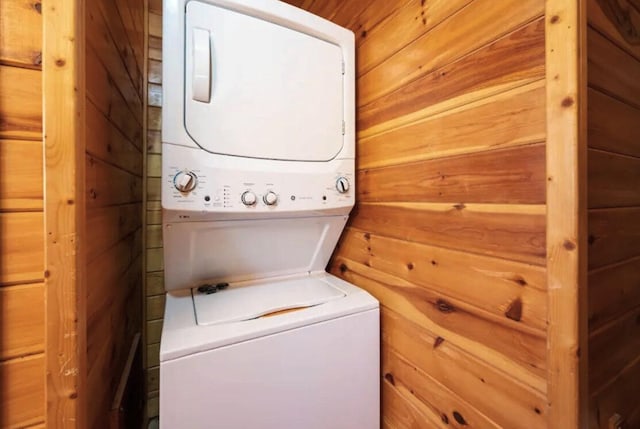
[162,144,355,214]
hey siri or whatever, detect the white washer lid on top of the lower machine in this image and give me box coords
[191,277,345,325]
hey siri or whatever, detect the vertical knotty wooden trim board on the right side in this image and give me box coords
[545,0,588,429]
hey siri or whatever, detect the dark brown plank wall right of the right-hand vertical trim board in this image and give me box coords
[587,0,640,429]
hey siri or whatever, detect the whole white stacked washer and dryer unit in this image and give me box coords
[160,0,380,429]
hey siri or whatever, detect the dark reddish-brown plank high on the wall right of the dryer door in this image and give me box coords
[357,18,544,130]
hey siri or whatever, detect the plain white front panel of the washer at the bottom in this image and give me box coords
[160,309,380,429]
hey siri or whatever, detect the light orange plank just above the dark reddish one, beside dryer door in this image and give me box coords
[358,0,544,106]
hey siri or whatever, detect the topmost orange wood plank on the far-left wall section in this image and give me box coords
[0,0,42,69]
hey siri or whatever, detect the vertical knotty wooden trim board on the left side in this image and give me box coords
[42,0,88,422]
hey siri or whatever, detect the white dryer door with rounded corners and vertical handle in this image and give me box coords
[185,1,344,161]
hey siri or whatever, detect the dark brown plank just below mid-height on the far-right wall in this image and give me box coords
[589,207,640,269]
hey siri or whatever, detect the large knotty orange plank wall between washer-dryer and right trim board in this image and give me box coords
[291,0,549,429]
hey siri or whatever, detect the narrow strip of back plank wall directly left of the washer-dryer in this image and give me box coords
[145,0,164,417]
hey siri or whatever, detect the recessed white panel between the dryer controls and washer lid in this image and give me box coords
[163,216,347,291]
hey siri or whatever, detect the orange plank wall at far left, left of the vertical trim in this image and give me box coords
[0,0,45,428]
